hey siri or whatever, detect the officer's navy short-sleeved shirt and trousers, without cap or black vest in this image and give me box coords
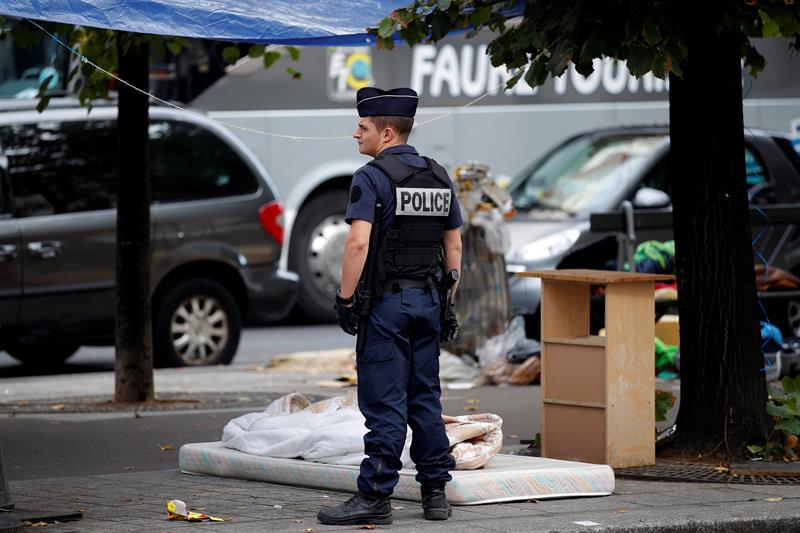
[345,141,463,496]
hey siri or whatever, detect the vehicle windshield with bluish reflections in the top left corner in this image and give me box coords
[0,28,69,98]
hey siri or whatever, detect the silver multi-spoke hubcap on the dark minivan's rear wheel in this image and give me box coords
[170,295,229,365]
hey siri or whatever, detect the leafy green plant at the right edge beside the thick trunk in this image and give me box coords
[747,376,800,461]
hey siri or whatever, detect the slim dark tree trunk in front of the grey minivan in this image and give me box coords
[114,32,154,402]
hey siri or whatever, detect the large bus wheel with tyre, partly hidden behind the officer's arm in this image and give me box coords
[289,191,350,322]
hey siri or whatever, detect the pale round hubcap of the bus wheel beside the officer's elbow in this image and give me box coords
[303,215,349,296]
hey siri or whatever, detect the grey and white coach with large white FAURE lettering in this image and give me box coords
[191,36,800,319]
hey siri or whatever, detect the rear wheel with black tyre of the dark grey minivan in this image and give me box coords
[153,278,242,366]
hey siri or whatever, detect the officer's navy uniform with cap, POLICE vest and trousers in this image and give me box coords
[345,87,463,498]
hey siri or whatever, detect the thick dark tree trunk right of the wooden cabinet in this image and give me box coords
[669,14,768,455]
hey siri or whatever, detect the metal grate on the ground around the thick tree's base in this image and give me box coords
[614,460,800,485]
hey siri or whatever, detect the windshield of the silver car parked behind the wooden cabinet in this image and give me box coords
[511,133,668,214]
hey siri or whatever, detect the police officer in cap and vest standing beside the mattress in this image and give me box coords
[317,87,463,525]
